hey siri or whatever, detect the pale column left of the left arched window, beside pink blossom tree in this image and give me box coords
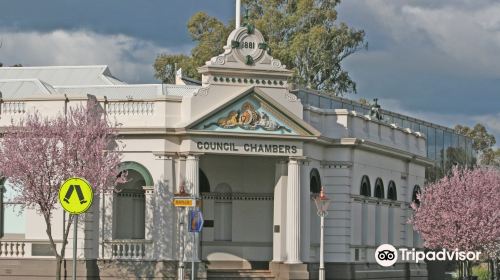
[99,188,114,259]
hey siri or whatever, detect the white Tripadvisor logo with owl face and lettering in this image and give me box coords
[375,244,481,267]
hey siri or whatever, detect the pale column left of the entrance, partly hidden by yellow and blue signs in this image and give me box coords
[184,154,200,261]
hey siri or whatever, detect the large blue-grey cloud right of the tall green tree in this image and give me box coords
[339,0,500,116]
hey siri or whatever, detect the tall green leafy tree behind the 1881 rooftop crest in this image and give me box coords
[154,0,367,95]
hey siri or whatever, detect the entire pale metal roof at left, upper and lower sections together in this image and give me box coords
[0,65,200,99]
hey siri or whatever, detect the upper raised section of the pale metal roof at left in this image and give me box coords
[0,65,124,86]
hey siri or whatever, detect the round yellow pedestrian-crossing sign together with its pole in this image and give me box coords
[59,178,94,280]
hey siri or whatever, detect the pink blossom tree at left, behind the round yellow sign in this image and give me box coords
[0,101,121,279]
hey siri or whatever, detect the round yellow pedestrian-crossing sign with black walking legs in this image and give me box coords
[59,177,94,215]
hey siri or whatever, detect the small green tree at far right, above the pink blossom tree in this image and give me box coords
[455,123,500,166]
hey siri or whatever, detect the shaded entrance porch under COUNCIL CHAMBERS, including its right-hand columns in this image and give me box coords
[193,154,310,279]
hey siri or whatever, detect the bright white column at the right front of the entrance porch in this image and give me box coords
[285,158,302,264]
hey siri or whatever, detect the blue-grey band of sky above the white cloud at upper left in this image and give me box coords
[0,0,234,47]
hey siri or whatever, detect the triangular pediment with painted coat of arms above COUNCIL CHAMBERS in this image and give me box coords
[188,88,318,136]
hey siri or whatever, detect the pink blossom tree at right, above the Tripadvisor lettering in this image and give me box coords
[410,167,500,278]
